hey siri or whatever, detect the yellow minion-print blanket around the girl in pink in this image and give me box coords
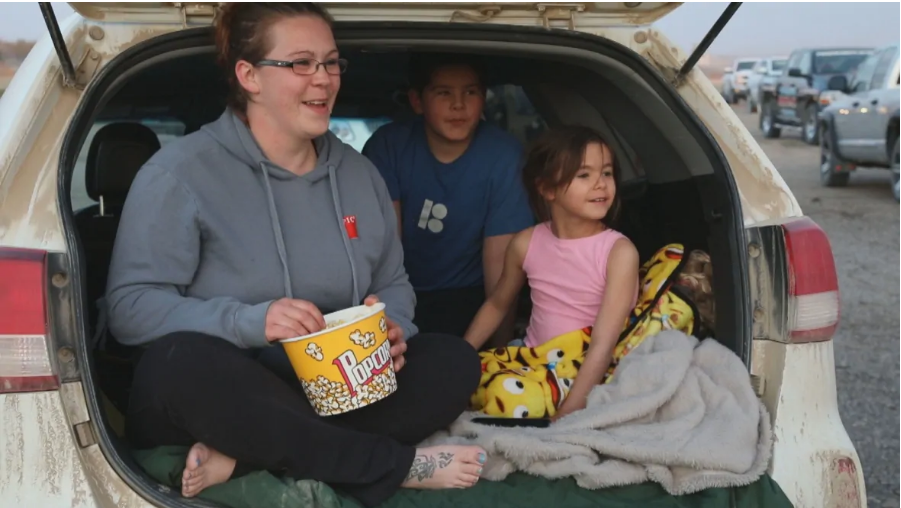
[470,244,698,418]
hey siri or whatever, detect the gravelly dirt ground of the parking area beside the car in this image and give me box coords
[735,103,899,508]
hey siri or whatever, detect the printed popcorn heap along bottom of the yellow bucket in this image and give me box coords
[301,369,397,416]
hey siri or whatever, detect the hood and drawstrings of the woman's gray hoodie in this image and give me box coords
[202,108,360,305]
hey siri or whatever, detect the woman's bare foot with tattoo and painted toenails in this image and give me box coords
[401,445,488,489]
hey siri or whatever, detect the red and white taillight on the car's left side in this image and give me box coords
[0,248,59,393]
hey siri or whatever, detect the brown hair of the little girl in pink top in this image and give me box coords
[522,125,620,227]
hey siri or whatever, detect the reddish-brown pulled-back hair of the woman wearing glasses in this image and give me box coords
[214,2,334,113]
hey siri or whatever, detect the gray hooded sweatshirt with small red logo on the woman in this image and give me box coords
[105,110,417,348]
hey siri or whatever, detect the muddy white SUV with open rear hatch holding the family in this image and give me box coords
[0,2,867,508]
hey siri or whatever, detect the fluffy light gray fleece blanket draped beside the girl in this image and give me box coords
[423,331,772,495]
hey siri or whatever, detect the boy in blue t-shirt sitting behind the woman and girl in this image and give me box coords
[363,55,534,345]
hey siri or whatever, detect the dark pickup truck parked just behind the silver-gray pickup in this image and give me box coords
[760,48,873,145]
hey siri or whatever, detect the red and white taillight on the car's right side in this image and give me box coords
[782,217,841,342]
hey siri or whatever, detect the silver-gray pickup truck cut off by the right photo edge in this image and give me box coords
[819,43,901,196]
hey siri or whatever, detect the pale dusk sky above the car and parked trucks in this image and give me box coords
[0,2,901,56]
